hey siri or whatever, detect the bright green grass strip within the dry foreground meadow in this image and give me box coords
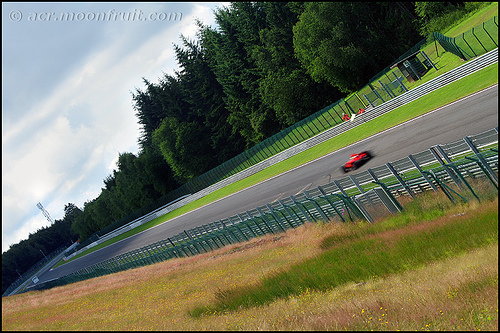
[191,192,498,316]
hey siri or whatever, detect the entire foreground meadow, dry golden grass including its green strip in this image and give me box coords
[2,190,498,331]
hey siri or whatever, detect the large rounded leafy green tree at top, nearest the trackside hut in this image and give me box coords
[293,2,423,93]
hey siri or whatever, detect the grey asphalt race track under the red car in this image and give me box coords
[33,85,498,282]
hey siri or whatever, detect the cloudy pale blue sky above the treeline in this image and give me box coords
[2,2,228,252]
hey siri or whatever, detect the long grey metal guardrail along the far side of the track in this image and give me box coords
[61,48,498,259]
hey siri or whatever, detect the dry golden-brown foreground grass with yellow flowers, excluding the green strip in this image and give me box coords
[2,192,498,330]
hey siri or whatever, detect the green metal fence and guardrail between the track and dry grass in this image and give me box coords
[23,127,498,290]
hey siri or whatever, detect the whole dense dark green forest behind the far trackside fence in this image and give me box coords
[2,2,479,293]
